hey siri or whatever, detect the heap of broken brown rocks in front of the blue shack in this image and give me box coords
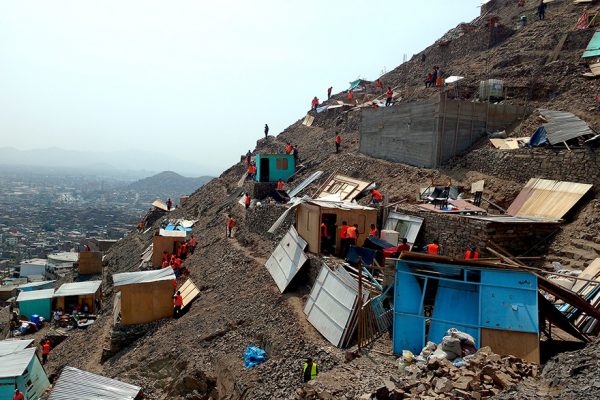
[358,347,538,400]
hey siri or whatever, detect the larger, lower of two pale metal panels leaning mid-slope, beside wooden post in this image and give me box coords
[304,264,358,346]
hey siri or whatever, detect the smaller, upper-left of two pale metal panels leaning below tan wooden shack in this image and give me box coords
[265,226,308,293]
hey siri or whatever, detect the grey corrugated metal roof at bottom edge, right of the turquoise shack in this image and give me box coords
[48,367,142,400]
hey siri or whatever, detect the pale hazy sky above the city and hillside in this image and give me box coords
[0,0,482,175]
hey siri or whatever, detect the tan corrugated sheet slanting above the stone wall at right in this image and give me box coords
[507,178,592,219]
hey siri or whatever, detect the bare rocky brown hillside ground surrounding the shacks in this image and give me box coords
[48,0,600,399]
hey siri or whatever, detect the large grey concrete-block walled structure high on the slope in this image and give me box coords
[360,96,528,168]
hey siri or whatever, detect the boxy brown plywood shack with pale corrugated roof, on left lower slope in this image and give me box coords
[113,268,175,325]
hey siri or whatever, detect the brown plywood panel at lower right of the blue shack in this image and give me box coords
[481,328,540,364]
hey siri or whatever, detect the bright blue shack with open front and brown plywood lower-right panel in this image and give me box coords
[393,253,540,363]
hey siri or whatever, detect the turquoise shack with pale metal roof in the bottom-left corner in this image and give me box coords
[0,340,50,400]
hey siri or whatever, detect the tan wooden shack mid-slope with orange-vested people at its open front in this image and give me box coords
[296,200,377,254]
